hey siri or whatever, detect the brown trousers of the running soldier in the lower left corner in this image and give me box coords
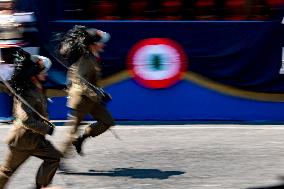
[0,139,61,189]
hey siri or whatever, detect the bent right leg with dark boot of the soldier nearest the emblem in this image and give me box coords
[73,104,115,154]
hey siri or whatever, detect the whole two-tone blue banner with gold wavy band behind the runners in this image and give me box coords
[0,20,284,121]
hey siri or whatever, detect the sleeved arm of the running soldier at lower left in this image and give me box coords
[15,96,51,135]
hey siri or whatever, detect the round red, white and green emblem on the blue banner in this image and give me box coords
[128,38,187,89]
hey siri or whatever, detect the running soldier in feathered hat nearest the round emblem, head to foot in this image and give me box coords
[59,26,115,155]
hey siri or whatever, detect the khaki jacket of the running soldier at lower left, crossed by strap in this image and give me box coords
[7,86,50,150]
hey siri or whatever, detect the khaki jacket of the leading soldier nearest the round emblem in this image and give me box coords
[67,54,101,109]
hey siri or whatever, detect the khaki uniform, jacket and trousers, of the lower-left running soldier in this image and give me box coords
[0,50,61,189]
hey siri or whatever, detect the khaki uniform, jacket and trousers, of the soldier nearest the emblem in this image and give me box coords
[63,53,115,153]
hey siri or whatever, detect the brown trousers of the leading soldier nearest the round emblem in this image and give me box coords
[62,100,115,155]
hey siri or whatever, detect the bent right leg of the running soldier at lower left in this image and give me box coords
[32,139,61,187]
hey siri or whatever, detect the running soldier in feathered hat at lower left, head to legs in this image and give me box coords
[0,49,61,189]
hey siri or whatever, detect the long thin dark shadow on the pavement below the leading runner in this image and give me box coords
[60,168,185,180]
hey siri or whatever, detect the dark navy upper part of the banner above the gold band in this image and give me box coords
[46,20,284,93]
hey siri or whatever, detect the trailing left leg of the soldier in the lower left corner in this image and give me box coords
[0,147,30,189]
